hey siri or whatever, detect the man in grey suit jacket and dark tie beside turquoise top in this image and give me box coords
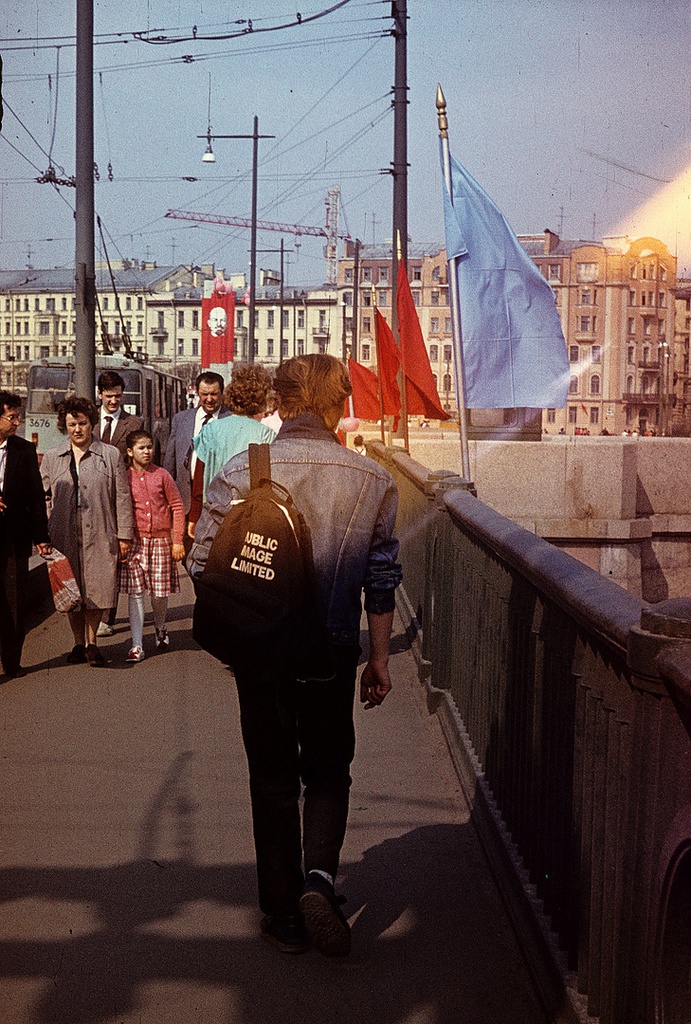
[163,371,230,547]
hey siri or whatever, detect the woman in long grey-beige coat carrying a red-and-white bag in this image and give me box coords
[41,395,134,668]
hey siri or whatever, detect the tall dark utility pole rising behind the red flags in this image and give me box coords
[391,0,407,437]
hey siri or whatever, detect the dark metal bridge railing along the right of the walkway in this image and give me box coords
[369,443,691,1024]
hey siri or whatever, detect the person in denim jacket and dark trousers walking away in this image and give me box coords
[189,354,401,955]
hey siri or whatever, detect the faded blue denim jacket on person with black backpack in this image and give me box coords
[188,413,402,644]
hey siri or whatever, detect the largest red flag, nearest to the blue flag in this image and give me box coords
[396,268,449,420]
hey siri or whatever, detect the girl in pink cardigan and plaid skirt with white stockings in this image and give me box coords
[118,430,184,663]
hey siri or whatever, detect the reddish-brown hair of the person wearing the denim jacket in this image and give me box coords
[273,354,352,422]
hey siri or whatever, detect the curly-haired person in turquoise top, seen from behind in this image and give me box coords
[189,362,275,537]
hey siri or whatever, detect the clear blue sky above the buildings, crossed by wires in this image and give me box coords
[0,0,691,284]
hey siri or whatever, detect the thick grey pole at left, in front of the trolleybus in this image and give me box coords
[75,0,96,399]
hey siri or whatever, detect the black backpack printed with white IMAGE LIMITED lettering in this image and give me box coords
[192,444,334,679]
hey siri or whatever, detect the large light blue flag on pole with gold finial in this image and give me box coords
[444,147,569,409]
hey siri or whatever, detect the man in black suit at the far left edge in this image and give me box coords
[0,391,51,679]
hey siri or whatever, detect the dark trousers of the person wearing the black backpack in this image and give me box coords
[235,647,359,914]
